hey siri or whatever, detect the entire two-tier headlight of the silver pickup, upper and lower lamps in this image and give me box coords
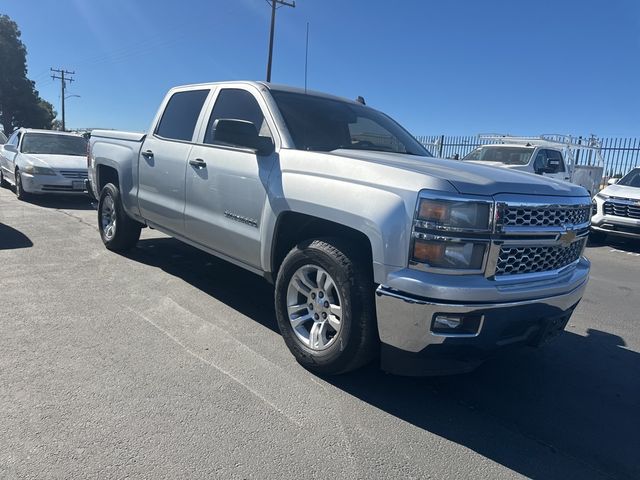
[410,192,494,273]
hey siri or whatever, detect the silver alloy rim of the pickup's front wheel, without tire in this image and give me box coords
[287,265,342,350]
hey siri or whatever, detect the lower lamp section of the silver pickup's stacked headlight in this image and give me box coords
[413,238,486,270]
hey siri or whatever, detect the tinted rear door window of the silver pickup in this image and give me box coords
[155,90,209,142]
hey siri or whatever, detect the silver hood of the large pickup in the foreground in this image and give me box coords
[327,149,588,197]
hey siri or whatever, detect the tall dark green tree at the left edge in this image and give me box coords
[0,15,56,134]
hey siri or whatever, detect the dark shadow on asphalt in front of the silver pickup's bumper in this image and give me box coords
[325,330,640,478]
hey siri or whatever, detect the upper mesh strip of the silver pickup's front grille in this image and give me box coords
[502,205,591,227]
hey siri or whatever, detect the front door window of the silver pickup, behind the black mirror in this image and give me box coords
[204,88,271,145]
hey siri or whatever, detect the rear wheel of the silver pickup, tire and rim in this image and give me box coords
[98,183,142,252]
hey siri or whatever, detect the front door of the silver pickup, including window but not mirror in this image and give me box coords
[185,85,277,267]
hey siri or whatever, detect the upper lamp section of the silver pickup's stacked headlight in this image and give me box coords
[417,198,491,232]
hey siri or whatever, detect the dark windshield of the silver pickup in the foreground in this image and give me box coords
[271,90,432,157]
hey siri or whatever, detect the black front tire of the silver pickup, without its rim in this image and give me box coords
[275,238,379,375]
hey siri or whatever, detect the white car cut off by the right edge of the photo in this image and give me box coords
[591,167,640,242]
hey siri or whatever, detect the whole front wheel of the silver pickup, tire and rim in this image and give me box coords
[275,239,378,375]
